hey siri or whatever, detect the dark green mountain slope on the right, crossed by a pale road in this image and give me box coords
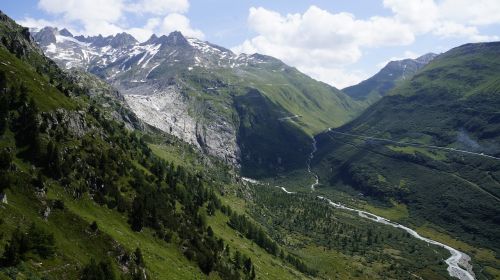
[313,42,500,276]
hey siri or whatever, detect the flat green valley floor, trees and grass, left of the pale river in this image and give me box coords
[248,186,448,279]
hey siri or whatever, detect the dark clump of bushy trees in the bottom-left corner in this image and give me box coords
[0,223,55,267]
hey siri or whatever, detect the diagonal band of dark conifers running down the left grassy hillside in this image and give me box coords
[0,85,255,279]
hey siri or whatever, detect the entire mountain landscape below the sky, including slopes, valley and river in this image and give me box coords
[0,7,500,280]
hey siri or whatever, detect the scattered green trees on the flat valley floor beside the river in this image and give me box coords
[251,186,452,278]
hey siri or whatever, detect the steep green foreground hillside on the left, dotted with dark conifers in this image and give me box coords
[0,11,312,279]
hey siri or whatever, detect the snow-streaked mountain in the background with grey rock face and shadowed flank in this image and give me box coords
[33,27,362,176]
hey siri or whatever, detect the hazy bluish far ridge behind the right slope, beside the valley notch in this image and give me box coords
[342,53,437,103]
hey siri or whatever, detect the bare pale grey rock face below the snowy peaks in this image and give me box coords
[121,84,239,165]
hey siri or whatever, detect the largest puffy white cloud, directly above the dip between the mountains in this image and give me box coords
[233,6,415,87]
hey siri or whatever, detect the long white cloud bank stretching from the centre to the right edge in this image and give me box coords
[233,0,500,87]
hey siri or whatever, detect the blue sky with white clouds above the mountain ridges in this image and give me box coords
[1,0,500,88]
